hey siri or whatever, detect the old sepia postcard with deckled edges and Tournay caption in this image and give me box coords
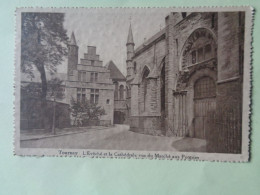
[14,7,253,162]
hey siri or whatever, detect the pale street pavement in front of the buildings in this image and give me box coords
[21,125,203,151]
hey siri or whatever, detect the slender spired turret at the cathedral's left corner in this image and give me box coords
[126,23,135,79]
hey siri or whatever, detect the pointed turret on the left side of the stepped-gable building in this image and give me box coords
[68,32,79,76]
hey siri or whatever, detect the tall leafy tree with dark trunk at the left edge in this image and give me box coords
[21,12,68,99]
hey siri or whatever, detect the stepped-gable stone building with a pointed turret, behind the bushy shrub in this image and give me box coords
[66,33,114,125]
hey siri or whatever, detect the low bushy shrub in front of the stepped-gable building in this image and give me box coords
[71,98,105,126]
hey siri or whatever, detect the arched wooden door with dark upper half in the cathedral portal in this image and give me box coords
[194,76,216,139]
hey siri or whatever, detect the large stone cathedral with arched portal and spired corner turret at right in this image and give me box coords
[126,12,245,153]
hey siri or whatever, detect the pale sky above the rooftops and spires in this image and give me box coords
[58,8,174,75]
